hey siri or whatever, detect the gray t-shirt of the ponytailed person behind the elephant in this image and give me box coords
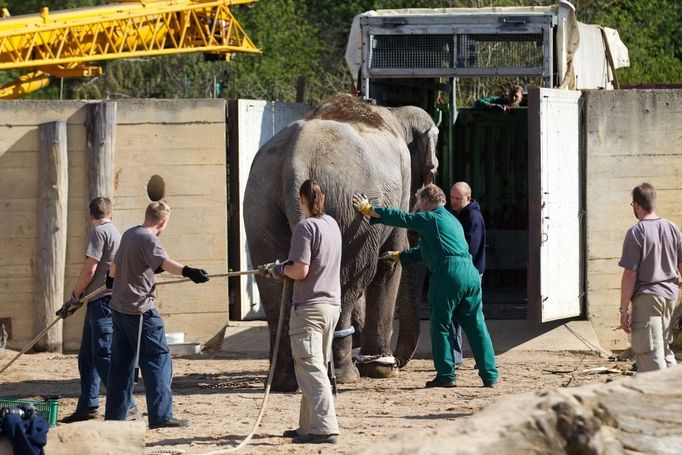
[289,215,341,305]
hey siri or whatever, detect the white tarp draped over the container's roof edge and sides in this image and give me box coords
[345,0,630,89]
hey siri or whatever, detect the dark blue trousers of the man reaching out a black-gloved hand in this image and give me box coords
[104,309,173,425]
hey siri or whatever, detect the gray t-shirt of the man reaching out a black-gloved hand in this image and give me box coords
[110,226,168,315]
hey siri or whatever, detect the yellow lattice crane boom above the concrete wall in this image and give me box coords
[0,0,260,99]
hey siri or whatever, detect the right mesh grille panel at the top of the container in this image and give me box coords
[456,34,542,68]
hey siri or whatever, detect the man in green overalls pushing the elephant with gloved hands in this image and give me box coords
[353,185,498,387]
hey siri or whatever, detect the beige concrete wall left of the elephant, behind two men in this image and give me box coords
[0,100,228,349]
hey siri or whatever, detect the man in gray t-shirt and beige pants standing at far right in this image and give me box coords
[618,183,682,372]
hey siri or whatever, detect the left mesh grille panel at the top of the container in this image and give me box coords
[370,35,453,69]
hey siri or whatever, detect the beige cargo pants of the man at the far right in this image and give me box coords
[630,294,677,373]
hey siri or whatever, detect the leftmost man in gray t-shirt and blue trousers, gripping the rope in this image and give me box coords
[62,197,130,423]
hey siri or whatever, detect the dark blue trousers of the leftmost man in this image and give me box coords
[76,296,113,412]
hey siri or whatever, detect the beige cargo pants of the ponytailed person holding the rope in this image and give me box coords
[289,303,341,435]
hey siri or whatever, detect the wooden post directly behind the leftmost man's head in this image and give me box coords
[85,101,116,205]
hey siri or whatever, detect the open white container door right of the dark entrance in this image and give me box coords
[528,88,583,322]
